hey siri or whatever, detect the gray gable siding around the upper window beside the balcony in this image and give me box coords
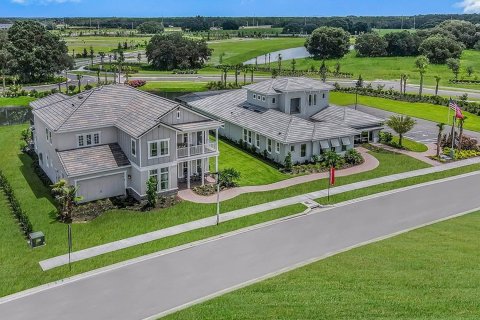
[140,125,177,167]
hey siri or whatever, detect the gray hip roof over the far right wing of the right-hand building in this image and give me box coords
[311,105,385,129]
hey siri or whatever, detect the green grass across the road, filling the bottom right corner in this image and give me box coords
[165,212,480,319]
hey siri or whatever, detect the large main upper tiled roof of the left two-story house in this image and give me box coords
[32,85,196,138]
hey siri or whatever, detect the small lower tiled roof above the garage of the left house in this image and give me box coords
[57,143,130,177]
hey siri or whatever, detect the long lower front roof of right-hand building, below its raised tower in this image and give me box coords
[189,89,359,143]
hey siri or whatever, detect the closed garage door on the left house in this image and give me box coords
[77,172,125,202]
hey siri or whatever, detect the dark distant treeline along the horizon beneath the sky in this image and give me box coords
[0,14,480,33]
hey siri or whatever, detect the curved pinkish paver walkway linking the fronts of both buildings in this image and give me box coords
[178,147,380,203]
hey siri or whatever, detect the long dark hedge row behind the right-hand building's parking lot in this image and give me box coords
[334,83,480,116]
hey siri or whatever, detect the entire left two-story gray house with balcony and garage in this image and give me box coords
[31,85,222,202]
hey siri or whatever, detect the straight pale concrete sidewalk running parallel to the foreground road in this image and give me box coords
[40,157,480,271]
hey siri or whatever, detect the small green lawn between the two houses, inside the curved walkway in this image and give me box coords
[214,140,292,186]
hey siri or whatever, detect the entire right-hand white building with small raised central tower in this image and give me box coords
[179,78,383,163]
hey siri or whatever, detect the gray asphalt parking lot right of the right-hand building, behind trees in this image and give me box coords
[350,105,480,144]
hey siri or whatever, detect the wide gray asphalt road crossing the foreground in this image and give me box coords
[0,174,480,320]
